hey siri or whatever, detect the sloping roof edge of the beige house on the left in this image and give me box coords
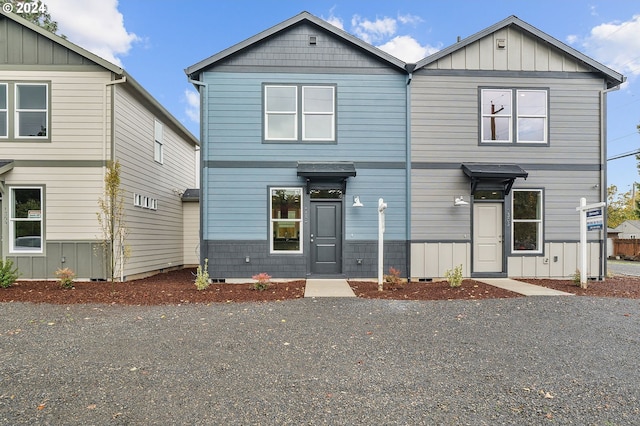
[0,8,200,146]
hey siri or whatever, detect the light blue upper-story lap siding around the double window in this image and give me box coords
[206,73,406,161]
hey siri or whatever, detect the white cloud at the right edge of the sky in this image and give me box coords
[582,15,640,76]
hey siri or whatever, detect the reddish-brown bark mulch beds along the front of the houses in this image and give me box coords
[0,269,640,305]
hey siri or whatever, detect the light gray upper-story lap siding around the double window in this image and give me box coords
[411,76,602,164]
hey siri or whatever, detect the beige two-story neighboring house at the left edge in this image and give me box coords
[0,12,199,280]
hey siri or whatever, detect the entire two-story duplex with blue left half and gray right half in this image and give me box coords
[185,12,624,280]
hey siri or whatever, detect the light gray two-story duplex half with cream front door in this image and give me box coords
[410,16,624,278]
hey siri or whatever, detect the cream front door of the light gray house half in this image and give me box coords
[473,203,503,273]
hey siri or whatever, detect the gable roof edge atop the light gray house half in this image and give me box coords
[416,15,626,88]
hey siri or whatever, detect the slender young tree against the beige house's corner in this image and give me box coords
[97,161,130,287]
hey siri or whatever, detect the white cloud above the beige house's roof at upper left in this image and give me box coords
[46,0,140,66]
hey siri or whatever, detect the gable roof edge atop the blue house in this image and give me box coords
[184,12,406,78]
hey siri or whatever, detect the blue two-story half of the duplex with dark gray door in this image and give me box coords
[185,12,408,279]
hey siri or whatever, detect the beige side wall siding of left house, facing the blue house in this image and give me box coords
[114,87,195,276]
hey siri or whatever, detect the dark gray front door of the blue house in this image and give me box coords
[310,201,342,274]
